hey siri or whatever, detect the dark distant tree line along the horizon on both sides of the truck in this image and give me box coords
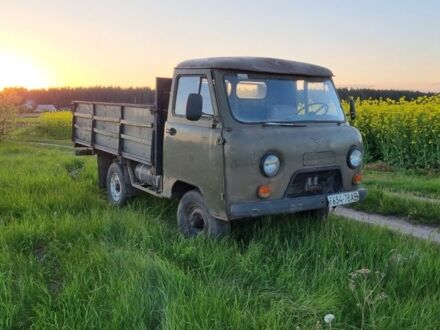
[1,86,434,109]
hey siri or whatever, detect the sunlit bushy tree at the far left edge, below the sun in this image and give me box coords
[0,89,21,142]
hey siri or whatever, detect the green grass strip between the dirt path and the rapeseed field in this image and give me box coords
[350,171,440,224]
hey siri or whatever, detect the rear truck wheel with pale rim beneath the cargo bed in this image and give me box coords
[107,163,129,206]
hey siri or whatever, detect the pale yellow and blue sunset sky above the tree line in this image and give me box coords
[0,0,440,92]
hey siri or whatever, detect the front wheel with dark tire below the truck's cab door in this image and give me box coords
[177,190,231,238]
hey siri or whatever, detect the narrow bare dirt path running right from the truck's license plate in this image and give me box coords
[333,207,440,243]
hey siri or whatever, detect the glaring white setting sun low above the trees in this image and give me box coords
[0,53,51,90]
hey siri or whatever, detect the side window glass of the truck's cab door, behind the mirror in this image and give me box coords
[174,76,213,116]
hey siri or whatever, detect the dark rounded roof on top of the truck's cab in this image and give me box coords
[177,57,333,77]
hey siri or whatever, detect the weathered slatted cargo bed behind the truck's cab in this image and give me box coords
[72,78,172,175]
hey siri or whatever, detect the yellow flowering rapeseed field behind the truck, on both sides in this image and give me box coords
[40,95,440,169]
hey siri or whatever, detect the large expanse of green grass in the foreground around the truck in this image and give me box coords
[0,142,440,329]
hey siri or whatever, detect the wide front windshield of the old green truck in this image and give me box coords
[224,73,345,123]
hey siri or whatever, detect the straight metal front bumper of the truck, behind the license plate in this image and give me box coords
[230,188,367,219]
